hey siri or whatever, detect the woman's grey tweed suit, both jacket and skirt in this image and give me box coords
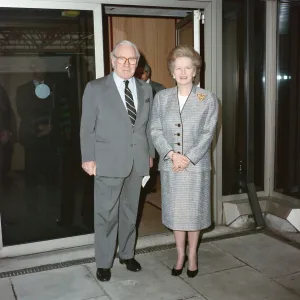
[150,86,218,231]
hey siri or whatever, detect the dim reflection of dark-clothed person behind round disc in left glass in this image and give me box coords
[16,58,58,186]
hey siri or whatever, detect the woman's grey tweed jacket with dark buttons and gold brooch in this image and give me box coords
[150,86,218,172]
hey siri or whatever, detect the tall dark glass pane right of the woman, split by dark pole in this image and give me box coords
[222,0,265,195]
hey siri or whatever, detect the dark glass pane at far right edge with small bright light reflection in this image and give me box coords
[275,1,300,199]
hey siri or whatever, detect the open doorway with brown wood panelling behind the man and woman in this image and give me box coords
[103,5,204,236]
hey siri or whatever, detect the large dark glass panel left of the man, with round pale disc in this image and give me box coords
[0,9,95,246]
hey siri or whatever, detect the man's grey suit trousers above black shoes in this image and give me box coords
[94,164,142,268]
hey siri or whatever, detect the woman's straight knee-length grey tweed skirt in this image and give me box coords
[160,171,211,231]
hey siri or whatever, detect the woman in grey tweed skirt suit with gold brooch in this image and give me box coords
[150,46,218,277]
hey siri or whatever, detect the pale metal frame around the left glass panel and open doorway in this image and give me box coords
[0,0,222,258]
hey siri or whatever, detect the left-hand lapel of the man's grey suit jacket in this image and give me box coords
[105,73,132,127]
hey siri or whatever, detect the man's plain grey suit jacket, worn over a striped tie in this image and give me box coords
[80,74,155,177]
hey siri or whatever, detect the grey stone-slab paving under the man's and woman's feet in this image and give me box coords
[0,232,300,300]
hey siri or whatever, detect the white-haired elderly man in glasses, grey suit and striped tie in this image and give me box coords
[80,40,155,281]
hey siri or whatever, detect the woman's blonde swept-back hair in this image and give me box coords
[167,45,202,75]
